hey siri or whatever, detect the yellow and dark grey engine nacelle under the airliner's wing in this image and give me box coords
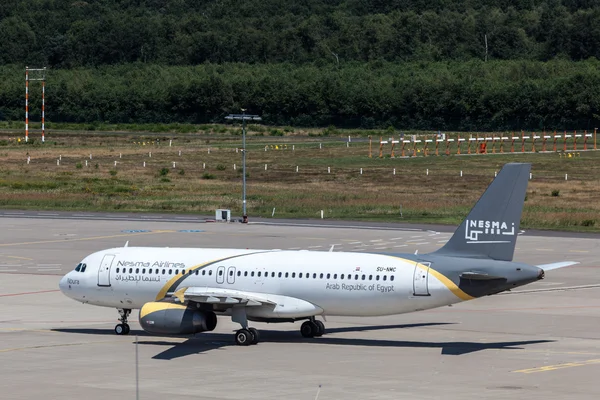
[140,302,217,335]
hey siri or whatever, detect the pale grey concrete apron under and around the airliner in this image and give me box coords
[0,216,600,400]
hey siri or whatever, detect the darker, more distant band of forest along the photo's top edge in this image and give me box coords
[0,0,600,68]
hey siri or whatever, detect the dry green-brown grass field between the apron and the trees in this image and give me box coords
[0,127,600,231]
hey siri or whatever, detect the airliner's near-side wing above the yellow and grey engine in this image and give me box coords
[173,287,277,307]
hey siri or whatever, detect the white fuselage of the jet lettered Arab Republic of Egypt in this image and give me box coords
[60,247,466,318]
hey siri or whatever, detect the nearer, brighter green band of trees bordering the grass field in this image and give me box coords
[0,59,600,131]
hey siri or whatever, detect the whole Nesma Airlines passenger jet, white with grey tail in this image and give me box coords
[59,163,577,346]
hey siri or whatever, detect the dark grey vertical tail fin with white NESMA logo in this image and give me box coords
[435,163,531,261]
